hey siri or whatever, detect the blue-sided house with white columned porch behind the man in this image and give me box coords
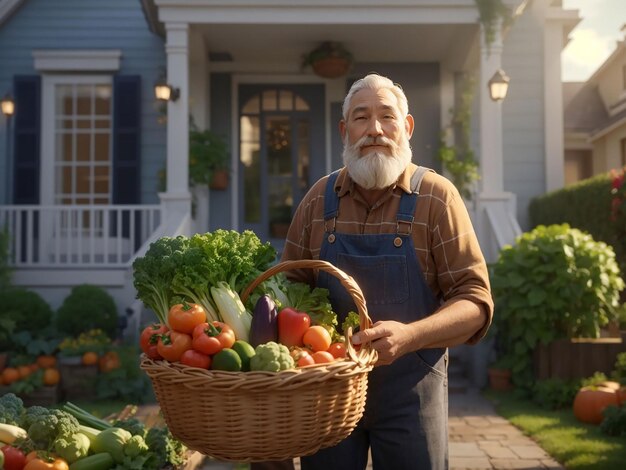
[0,0,579,352]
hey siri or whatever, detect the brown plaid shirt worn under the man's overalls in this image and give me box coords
[282,164,493,343]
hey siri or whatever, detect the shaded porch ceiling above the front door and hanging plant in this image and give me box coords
[192,24,478,70]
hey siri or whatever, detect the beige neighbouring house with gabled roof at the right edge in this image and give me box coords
[563,25,626,184]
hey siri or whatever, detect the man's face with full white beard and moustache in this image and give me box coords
[339,89,413,189]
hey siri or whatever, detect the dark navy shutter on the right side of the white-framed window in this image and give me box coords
[112,75,141,204]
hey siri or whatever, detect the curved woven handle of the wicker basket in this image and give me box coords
[240,259,376,364]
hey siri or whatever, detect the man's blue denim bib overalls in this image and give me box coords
[301,167,448,470]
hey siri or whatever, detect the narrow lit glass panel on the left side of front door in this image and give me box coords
[240,116,261,223]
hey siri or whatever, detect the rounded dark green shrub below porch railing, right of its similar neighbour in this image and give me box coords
[57,284,118,338]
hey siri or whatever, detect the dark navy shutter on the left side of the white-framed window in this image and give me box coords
[13,75,41,204]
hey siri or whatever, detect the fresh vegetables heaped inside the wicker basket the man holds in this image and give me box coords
[133,230,359,372]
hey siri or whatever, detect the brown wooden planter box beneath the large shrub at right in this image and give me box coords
[533,338,626,380]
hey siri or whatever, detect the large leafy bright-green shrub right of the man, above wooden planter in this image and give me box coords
[490,224,624,390]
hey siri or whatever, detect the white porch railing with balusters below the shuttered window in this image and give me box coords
[0,204,162,268]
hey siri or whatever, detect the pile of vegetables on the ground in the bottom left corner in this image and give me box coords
[0,393,187,470]
